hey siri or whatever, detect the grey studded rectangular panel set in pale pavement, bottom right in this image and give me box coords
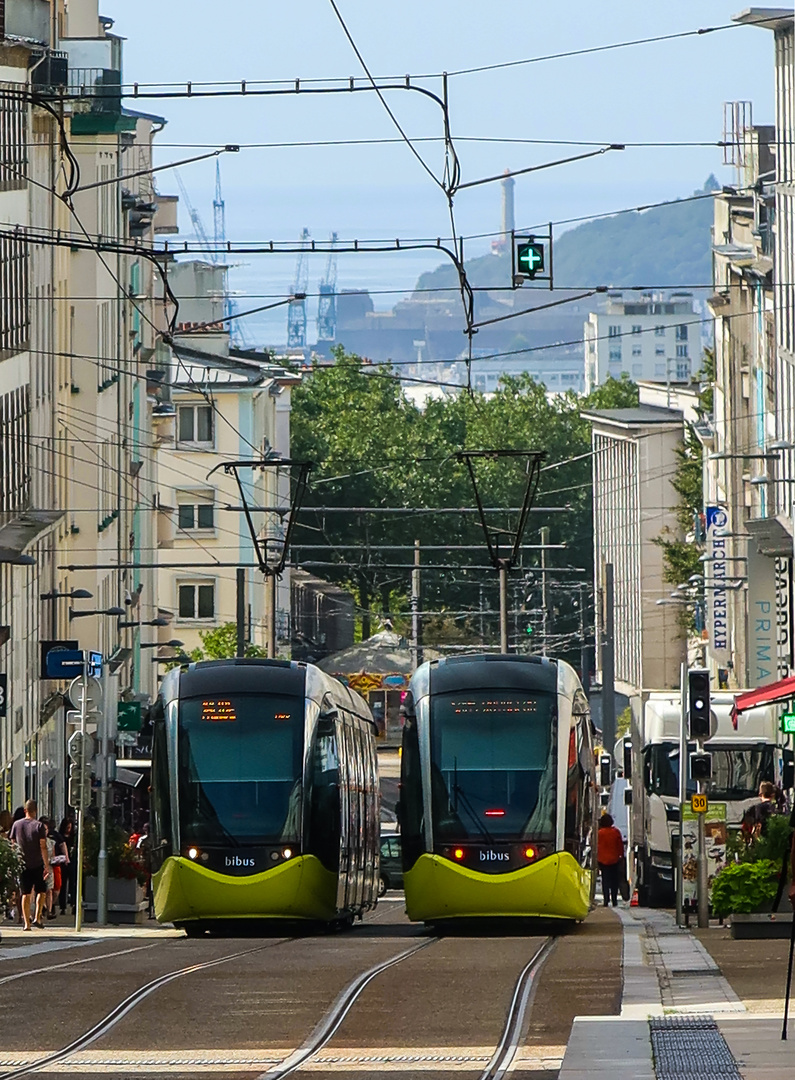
[649,1016,742,1080]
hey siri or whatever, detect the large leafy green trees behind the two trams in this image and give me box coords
[292,349,637,663]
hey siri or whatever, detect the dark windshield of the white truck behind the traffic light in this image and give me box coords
[645,742,773,799]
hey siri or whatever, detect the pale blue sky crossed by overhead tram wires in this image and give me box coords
[100,0,773,345]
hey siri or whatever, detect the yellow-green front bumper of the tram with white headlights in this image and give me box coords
[152,855,337,922]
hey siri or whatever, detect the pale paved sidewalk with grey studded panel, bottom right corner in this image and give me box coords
[560,907,795,1080]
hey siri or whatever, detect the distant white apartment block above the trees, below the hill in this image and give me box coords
[584,292,701,393]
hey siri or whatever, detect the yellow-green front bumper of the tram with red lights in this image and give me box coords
[403,852,591,922]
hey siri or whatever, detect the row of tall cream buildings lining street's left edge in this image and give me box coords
[0,0,173,816]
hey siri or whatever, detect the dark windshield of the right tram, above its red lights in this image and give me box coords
[431,689,556,843]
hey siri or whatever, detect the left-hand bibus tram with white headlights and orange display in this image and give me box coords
[151,659,379,936]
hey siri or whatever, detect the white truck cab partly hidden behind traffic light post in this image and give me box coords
[631,691,792,906]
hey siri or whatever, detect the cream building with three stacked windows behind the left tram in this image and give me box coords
[154,260,300,656]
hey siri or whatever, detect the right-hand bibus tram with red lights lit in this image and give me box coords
[399,654,597,923]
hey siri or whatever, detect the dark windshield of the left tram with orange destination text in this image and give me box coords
[178,693,304,847]
